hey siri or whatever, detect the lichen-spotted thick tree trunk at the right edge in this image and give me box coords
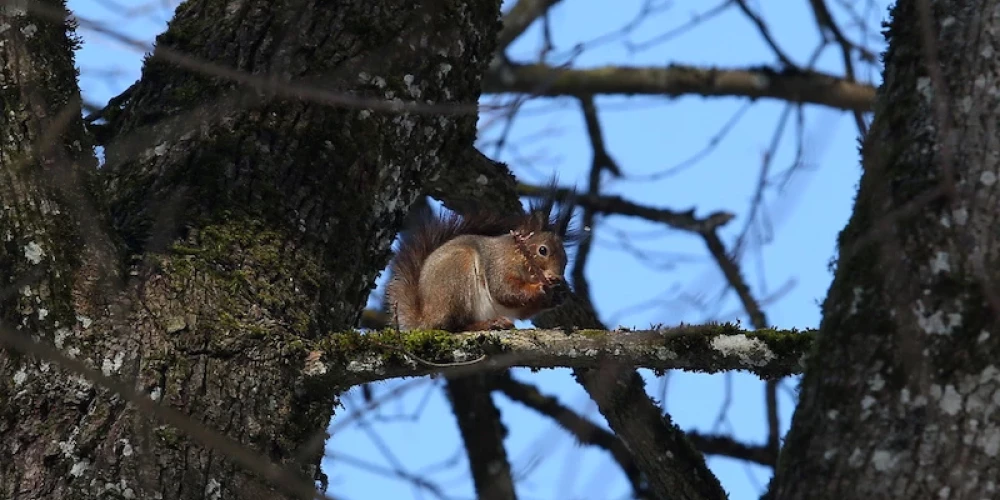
[771,0,1000,499]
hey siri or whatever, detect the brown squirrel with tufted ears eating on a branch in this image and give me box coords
[386,191,579,331]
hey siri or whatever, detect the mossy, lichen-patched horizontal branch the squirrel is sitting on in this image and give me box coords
[305,323,815,388]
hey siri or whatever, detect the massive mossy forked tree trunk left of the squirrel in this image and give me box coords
[0,0,499,499]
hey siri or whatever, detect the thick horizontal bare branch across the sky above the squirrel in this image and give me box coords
[483,64,875,112]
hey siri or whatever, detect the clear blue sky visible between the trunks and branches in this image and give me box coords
[69,0,888,500]
